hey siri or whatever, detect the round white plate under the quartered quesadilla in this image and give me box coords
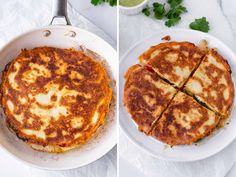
[119,29,236,161]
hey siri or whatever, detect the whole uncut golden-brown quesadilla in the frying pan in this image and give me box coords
[1,47,112,152]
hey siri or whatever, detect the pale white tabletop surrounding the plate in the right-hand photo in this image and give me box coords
[119,0,236,177]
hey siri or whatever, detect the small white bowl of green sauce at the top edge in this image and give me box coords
[119,0,149,15]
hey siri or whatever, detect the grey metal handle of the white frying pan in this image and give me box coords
[50,0,71,25]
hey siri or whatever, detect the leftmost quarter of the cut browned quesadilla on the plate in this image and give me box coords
[123,65,176,133]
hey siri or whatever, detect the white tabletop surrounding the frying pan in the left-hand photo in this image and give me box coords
[0,0,117,177]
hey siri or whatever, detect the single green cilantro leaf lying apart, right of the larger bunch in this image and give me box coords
[189,17,210,32]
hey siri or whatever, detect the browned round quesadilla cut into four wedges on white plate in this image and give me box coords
[124,40,234,145]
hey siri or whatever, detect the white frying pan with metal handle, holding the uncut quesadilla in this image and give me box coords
[0,0,118,170]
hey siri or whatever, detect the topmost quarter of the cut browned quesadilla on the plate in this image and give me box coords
[139,42,203,88]
